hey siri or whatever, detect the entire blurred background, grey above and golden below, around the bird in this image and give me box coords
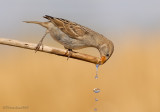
[0,0,160,112]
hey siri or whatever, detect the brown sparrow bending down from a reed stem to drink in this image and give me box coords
[24,15,114,64]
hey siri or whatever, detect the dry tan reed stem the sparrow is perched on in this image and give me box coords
[0,38,100,64]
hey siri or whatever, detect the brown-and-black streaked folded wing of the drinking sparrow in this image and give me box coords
[44,15,90,39]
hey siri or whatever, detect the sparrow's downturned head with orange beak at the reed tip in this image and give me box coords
[99,40,114,64]
